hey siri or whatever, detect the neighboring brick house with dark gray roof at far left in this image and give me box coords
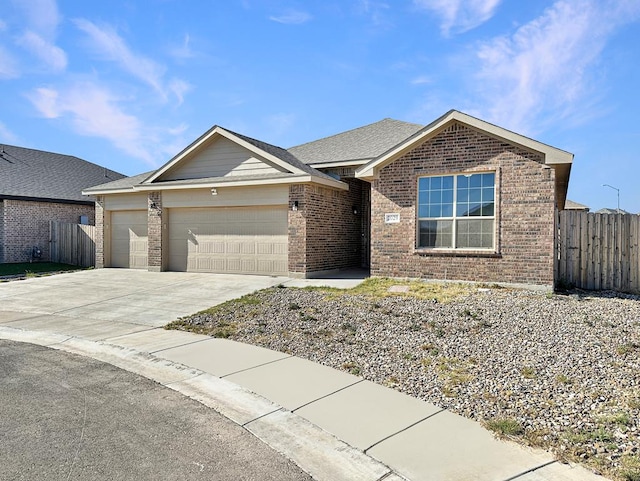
[0,144,124,262]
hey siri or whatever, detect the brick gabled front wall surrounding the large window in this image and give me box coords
[371,124,555,285]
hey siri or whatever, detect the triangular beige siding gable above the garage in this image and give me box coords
[159,137,284,180]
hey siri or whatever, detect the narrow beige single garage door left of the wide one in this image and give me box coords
[111,210,148,269]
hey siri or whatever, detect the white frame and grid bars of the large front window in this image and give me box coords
[415,170,498,254]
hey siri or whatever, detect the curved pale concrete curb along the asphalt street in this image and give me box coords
[0,326,408,481]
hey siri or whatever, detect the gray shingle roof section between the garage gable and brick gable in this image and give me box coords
[288,119,424,165]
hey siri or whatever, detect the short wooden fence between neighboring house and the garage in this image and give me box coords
[49,221,96,267]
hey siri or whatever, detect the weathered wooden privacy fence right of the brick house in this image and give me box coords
[556,210,640,293]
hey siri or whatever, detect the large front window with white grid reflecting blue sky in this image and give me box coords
[418,172,495,249]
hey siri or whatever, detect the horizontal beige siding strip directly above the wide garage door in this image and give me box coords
[162,185,289,208]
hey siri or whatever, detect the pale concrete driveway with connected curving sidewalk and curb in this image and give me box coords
[0,269,603,481]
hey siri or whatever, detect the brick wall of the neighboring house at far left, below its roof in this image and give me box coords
[2,199,95,262]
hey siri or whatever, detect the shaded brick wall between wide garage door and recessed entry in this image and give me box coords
[289,179,363,274]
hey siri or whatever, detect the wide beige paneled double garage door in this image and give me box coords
[169,206,288,275]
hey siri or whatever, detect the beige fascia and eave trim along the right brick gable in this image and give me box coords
[356,110,573,209]
